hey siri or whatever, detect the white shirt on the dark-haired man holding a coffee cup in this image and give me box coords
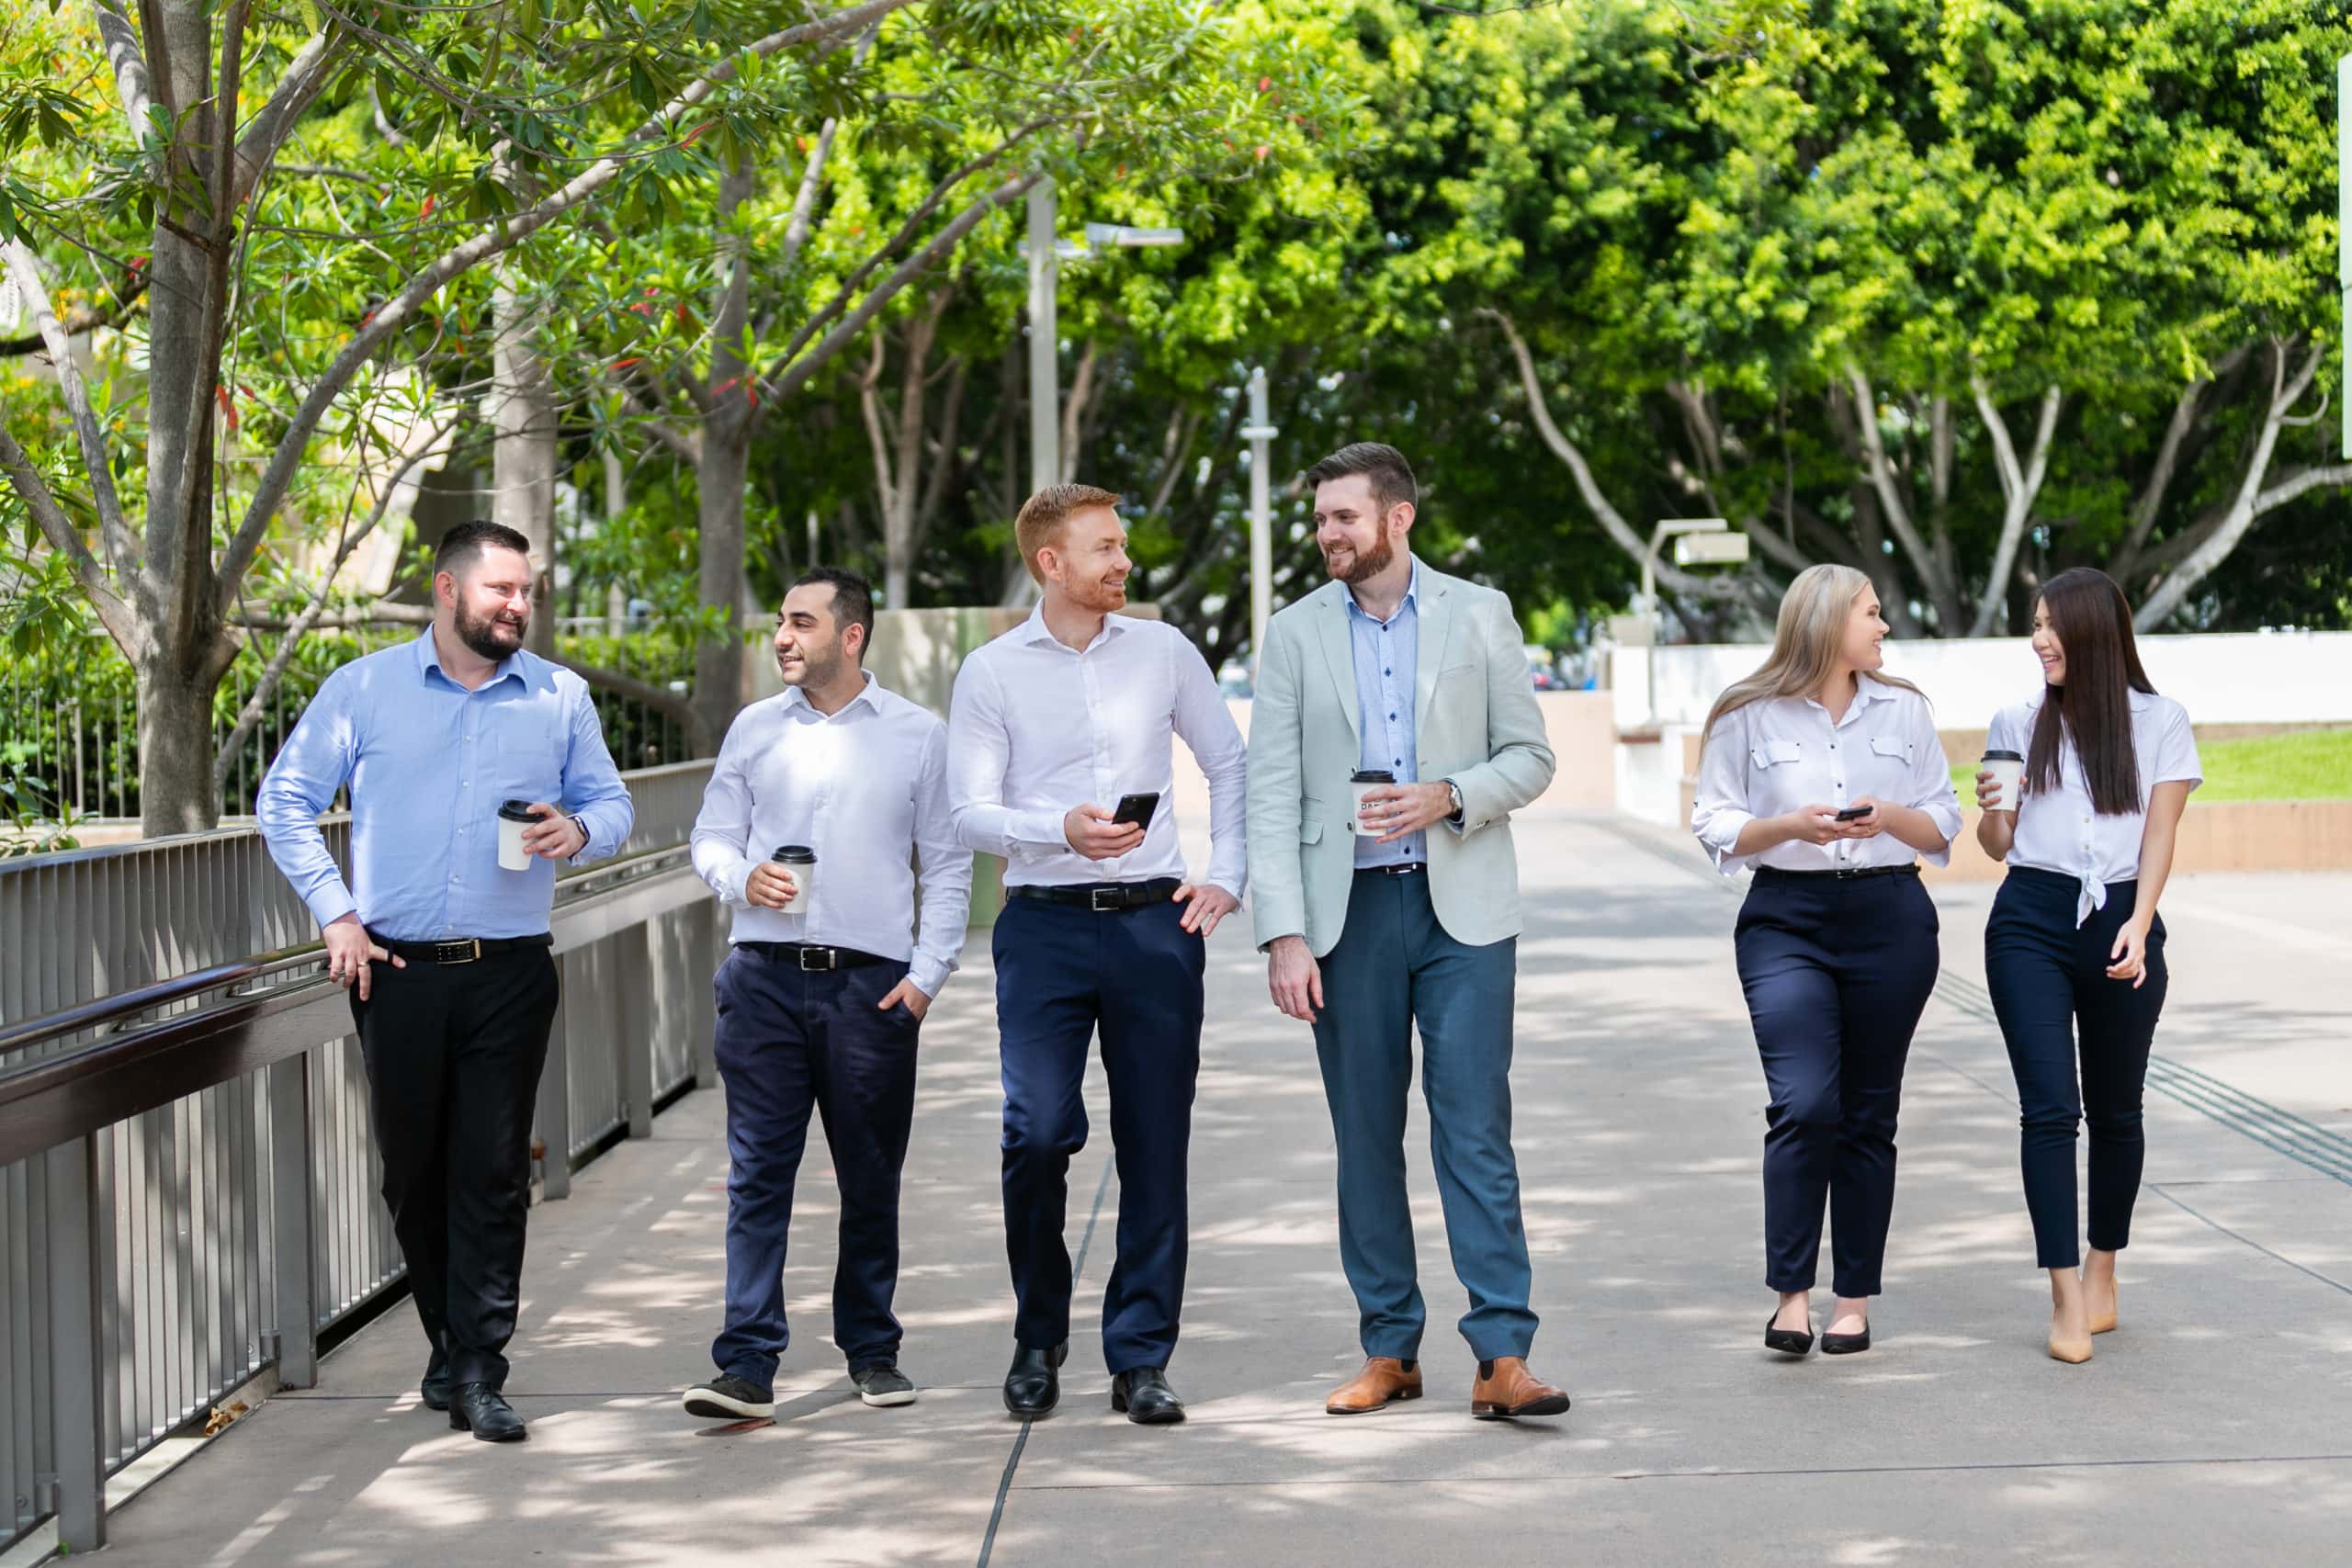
[694,674,971,997]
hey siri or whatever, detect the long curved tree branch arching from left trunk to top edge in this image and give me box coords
[217,0,912,606]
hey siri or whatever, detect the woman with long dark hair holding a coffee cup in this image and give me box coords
[1975,567,2204,1363]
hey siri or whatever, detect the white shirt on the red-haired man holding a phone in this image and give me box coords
[948,609,1249,898]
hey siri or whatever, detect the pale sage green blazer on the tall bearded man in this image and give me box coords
[1249,564,1555,957]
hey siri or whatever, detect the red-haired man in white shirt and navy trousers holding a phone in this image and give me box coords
[948,484,1247,1425]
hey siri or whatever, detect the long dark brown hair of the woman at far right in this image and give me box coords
[2025,567,2157,816]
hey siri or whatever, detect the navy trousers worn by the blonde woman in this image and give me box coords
[1734,867,1940,1295]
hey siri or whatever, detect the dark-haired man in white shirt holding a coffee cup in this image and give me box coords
[684,569,971,1420]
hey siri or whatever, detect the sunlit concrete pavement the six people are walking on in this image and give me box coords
[83,813,2352,1568]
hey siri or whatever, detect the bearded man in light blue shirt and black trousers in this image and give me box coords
[254,522,635,1443]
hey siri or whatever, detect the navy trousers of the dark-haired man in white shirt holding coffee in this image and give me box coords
[710,942,922,1387]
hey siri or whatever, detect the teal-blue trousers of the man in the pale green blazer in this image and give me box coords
[1315,870,1536,1361]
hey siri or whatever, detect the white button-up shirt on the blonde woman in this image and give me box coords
[1691,674,1959,877]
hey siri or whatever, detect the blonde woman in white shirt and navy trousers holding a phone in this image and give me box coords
[1691,567,1959,1357]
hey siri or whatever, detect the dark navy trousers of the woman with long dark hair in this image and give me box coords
[1985,865,2166,1269]
